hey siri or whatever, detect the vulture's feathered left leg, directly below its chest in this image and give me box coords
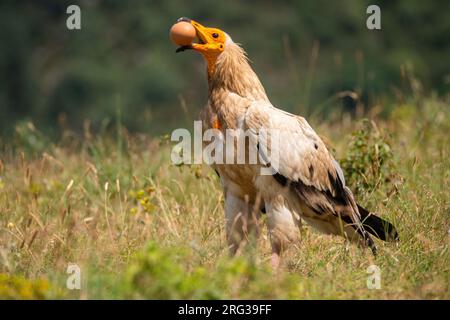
[225,192,261,255]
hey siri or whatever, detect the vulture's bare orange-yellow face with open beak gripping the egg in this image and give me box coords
[177,18,227,66]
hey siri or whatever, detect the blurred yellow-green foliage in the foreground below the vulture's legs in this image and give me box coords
[124,242,298,299]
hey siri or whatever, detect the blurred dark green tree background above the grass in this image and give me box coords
[0,0,450,135]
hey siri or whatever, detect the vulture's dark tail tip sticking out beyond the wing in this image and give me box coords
[358,204,399,241]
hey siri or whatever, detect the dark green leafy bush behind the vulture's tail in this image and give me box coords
[341,119,393,194]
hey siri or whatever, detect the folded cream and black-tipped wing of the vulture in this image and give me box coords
[243,102,398,250]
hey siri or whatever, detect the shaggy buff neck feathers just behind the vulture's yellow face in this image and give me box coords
[208,41,269,103]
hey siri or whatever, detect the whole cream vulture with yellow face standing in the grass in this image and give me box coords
[177,18,398,268]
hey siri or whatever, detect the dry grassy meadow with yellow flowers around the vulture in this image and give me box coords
[0,99,450,299]
